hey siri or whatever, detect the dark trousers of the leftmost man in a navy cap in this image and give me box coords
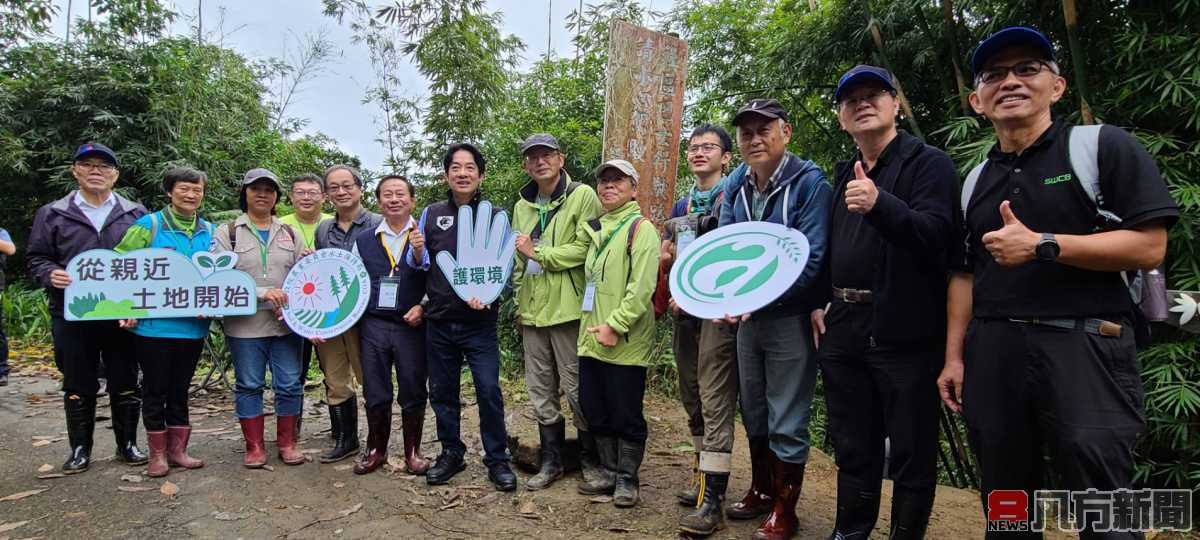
[50,317,140,401]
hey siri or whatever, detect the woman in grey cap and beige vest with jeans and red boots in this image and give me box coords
[212,169,305,468]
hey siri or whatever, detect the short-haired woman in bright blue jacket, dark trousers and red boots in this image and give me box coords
[114,167,212,476]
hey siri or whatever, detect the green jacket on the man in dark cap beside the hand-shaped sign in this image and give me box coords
[512,170,604,326]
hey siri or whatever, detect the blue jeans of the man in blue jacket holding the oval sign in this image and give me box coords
[738,316,817,463]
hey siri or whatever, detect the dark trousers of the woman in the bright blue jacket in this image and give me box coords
[133,335,204,431]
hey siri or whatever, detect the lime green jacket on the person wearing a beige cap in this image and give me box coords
[559,200,659,367]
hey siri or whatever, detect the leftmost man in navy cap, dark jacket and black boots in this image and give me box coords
[25,143,146,474]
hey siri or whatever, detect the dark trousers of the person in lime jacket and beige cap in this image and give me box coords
[580,356,646,443]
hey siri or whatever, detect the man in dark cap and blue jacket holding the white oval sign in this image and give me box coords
[706,100,833,539]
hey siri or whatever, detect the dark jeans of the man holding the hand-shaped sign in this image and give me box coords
[425,320,511,464]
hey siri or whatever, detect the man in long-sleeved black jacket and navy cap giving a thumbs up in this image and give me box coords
[812,66,959,540]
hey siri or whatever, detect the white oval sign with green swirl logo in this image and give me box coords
[670,221,809,319]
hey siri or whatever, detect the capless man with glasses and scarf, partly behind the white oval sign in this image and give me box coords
[661,124,738,535]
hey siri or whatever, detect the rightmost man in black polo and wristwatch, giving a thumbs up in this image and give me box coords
[938,26,1178,538]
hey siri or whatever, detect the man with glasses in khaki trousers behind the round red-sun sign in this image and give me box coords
[304,164,383,463]
